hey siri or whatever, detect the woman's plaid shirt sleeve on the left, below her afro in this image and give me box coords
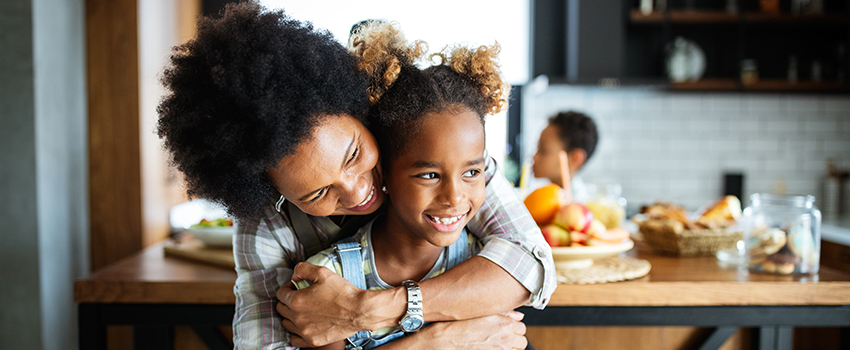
[233,208,305,349]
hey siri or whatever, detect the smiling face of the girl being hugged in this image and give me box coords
[385,108,484,247]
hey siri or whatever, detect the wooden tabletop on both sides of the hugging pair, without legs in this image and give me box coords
[74,242,850,306]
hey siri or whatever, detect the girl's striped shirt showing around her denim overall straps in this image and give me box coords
[299,220,481,339]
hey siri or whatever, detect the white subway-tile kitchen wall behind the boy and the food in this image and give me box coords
[522,81,850,211]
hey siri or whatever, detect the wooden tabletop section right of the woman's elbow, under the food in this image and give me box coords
[549,242,850,306]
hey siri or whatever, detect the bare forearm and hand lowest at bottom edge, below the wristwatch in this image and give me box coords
[394,311,528,350]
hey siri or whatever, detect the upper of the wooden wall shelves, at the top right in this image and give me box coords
[629,9,850,25]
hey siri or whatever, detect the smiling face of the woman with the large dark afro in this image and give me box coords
[268,114,384,216]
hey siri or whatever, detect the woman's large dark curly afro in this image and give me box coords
[157,2,368,218]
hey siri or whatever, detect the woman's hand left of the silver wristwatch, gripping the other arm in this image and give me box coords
[276,263,407,347]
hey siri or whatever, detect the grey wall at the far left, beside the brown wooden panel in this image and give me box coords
[0,0,89,349]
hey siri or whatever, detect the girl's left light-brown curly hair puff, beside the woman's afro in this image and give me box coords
[348,20,428,105]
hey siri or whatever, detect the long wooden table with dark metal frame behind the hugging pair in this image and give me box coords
[74,242,850,349]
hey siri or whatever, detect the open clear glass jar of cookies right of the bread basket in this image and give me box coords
[743,193,821,275]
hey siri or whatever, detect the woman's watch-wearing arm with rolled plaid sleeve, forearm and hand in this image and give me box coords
[277,159,556,346]
